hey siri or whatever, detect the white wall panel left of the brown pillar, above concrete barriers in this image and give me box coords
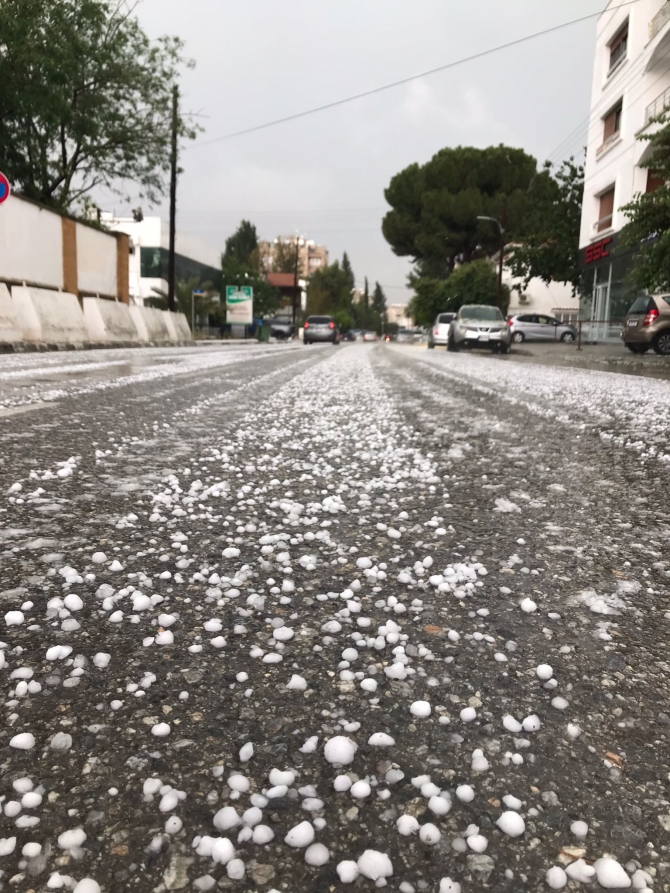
[0,195,63,289]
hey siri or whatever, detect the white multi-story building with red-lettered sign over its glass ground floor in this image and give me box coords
[579,0,670,335]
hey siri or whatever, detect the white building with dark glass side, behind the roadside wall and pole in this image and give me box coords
[101,213,221,304]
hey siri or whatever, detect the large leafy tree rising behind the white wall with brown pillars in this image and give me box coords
[0,0,195,210]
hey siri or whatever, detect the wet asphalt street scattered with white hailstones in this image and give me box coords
[0,343,670,893]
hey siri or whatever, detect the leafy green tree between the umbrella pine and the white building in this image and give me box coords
[505,158,584,291]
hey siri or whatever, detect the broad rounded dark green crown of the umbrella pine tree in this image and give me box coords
[382,145,537,278]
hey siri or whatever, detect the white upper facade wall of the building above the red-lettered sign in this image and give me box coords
[579,0,670,248]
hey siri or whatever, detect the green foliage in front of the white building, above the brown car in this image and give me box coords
[620,116,670,294]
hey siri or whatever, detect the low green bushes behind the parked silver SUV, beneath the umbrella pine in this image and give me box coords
[408,259,510,326]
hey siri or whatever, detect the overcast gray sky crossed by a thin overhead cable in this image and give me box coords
[117,0,605,303]
